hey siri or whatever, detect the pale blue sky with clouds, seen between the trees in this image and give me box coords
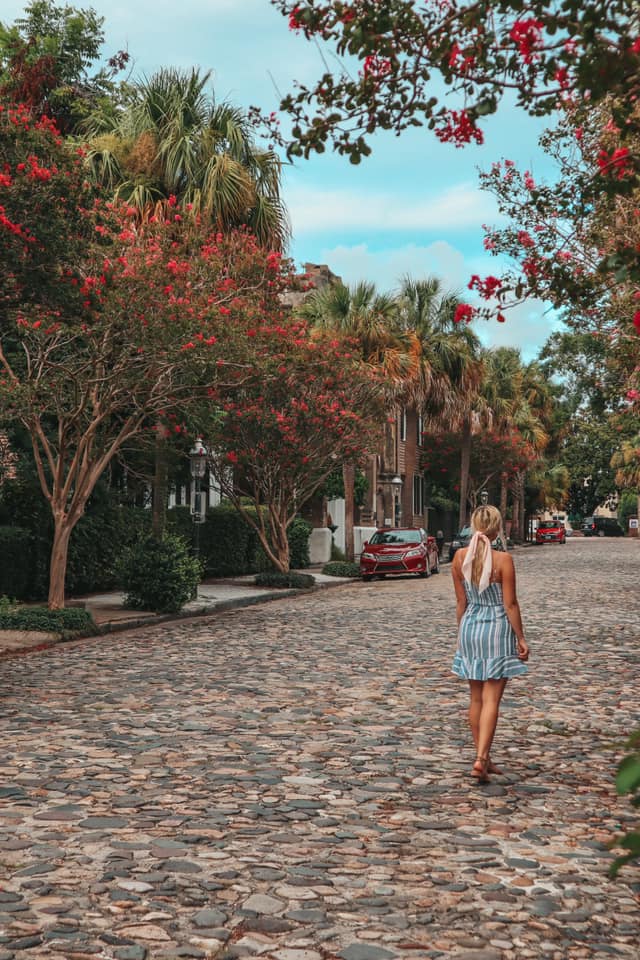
[5,0,558,361]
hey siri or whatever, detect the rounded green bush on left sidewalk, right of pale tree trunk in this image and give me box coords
[121,534,202,613]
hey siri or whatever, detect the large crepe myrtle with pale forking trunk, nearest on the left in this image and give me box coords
[0,105,298,609]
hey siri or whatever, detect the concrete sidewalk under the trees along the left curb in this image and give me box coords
[0,567,356,655]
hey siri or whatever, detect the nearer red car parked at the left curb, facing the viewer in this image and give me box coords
[360,527,440,580]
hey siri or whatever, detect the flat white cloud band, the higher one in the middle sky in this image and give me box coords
[286,183,496,234]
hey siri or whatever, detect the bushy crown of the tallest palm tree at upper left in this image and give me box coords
[84,69,289,250]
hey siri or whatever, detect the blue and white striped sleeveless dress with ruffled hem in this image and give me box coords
[451,580,527,680]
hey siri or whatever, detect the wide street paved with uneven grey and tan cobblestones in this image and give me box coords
[0,538,640,960]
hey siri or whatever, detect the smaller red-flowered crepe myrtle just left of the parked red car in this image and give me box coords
[208,315,384,572]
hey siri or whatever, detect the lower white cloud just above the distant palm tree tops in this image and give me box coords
[304,240,559,361]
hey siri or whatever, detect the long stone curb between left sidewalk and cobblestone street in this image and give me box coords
[0,577,361,660]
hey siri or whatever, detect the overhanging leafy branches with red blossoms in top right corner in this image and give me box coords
[270,0,640,308]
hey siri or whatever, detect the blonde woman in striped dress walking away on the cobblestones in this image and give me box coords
[451,506,529,782]
